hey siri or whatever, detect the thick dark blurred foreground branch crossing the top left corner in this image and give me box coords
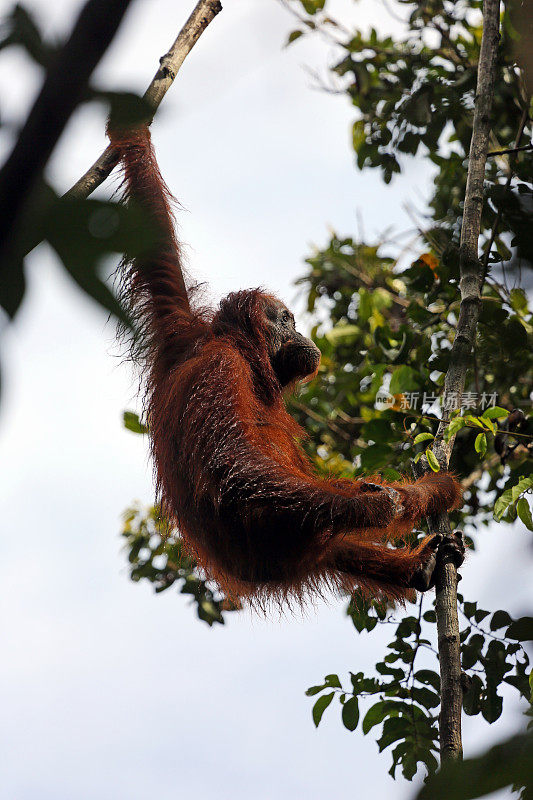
[0,0,135,269]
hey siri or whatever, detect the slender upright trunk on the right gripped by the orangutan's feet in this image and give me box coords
[417,0,500,761]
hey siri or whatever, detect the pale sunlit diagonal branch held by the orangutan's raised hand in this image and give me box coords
[65,0,222,199]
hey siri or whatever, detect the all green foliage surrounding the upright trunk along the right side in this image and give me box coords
[280,0,533,797]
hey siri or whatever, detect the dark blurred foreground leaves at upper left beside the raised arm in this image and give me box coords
[0,4,154,342]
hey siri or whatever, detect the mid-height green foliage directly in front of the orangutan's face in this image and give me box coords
[293,235,533,525]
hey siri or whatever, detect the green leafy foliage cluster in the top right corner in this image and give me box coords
[288,0,533,263]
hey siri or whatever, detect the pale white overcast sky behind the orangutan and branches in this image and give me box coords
[0,0,530,800]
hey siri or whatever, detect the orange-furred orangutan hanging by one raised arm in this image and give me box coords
[109,125,461,602]
